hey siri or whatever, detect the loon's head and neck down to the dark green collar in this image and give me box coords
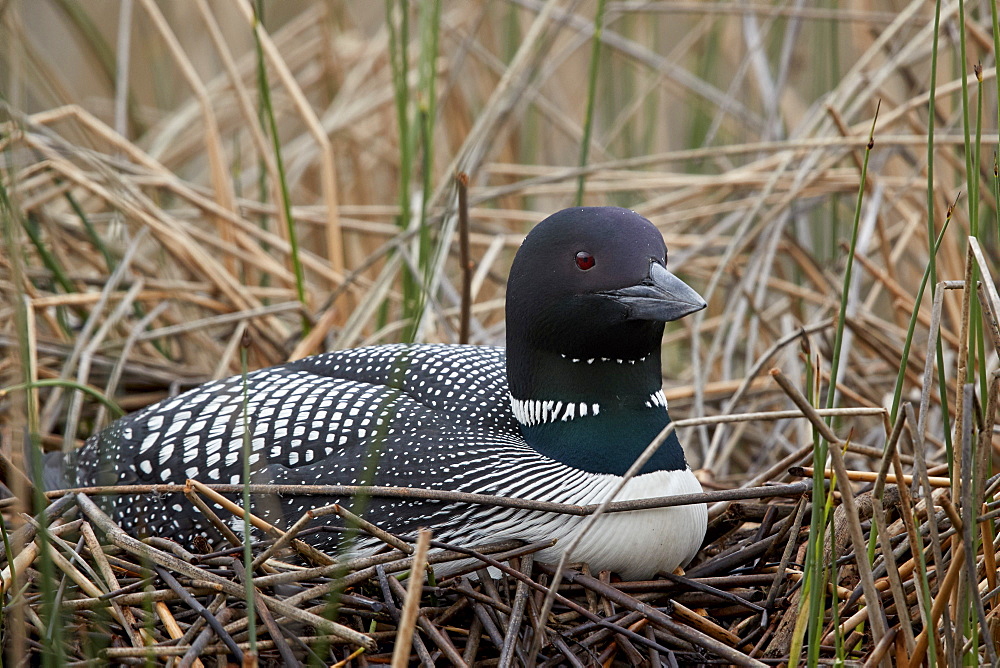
[507,207,706,472]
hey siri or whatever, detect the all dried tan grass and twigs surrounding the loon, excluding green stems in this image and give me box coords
[0,0,1000,665]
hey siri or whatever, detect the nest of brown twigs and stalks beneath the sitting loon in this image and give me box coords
[2,418,1000,666]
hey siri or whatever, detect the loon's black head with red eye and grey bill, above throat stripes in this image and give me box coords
[507,207,705,378]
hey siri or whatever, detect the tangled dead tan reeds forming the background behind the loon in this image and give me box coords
[0,0,998,665]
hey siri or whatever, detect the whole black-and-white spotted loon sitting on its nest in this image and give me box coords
[76,207,706,579]
